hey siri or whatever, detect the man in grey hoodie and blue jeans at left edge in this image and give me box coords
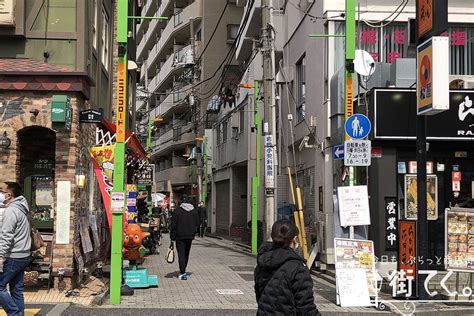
[0,182,31,316]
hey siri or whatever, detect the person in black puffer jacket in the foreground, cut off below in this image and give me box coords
[254,219,320,315]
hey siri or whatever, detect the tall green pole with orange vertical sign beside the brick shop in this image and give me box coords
[110,0,128,305]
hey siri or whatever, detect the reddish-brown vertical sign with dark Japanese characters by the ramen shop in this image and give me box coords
[398,220,416,277]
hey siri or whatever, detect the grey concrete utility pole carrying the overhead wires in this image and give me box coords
[262,0,277,240]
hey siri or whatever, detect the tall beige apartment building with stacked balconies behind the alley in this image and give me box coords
[136,0,241,197]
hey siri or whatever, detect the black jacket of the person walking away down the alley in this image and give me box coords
[170,203,200,240]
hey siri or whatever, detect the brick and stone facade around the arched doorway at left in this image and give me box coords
[0,91,103,288]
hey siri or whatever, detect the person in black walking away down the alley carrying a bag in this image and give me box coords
[170,203,199,280]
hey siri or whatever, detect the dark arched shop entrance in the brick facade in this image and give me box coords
[18,126,56,232]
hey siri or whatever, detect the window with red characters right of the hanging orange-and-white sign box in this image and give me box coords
[442,26,474,75]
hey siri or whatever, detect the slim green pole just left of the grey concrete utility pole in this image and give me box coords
[252,80,261,255]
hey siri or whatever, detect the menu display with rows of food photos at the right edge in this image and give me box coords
[445,208,474,272]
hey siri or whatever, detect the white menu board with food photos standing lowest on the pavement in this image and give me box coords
[334,238,377,306]
